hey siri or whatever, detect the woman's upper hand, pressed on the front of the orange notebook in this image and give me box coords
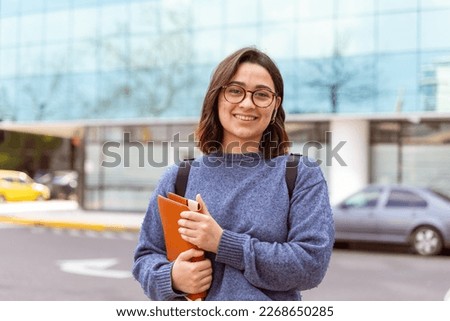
[178,194,223,253]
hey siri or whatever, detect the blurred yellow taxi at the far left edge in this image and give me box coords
[0,170,50,203]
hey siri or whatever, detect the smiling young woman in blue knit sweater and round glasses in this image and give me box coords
[133,48,334,301]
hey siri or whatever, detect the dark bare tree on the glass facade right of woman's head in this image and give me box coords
[306,45,377,113]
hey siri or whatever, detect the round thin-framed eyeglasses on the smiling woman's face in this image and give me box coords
[222,85,277,108]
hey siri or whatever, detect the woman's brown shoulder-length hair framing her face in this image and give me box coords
[196,47,289,158]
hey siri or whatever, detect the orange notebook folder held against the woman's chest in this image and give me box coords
[158,193,206,301]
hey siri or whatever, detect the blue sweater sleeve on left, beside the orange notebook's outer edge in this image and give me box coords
[132,166,184,301]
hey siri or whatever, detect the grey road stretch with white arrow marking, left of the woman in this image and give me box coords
[0,224,146,301]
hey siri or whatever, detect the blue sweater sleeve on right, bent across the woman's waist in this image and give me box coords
[216,164,334,291]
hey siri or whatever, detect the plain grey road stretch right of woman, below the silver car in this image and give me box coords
[303,244,450,301]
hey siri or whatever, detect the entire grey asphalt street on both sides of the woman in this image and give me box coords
[0,224,450,301]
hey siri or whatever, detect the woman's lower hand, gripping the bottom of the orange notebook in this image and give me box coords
[172,249,212,294]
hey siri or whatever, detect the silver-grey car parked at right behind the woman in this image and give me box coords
[333,185,450,255]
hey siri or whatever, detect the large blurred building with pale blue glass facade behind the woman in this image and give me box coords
[0,0,450,211]
